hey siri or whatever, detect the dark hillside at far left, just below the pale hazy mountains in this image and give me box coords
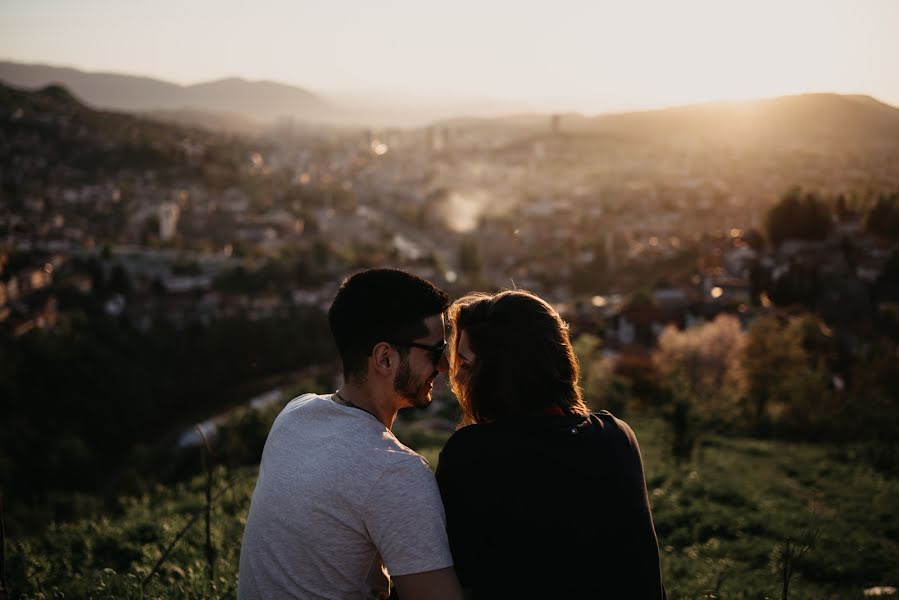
[0,84,259,189]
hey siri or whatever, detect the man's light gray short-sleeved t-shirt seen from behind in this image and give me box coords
[237,394,453,600]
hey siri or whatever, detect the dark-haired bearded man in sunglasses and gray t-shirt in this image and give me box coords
[238,269,462,600]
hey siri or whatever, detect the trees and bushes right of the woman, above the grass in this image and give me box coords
[577,307,899,471]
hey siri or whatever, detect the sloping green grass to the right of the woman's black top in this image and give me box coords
[632,419,899,599]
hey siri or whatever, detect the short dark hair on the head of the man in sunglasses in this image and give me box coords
[328,269,449,379]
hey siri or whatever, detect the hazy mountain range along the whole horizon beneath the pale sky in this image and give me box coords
[0,62,899,144]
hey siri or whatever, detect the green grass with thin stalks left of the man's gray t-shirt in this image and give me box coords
[7,468,256,599]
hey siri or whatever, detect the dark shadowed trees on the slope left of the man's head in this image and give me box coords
[0,308,335,532]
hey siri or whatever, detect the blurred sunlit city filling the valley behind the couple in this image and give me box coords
[0,82,899,348]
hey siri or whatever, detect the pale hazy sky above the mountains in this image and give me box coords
[0,0,899,112]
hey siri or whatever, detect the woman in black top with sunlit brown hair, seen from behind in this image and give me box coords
[437,290,664,599]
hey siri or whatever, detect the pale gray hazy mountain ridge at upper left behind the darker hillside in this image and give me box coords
[0,62,342,122]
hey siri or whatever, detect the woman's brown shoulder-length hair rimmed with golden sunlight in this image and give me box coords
[449,290,589,424]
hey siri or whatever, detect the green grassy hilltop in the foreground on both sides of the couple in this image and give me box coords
[6,418,899,600]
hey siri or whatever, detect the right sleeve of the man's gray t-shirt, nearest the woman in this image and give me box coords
[365,457,453,576]
